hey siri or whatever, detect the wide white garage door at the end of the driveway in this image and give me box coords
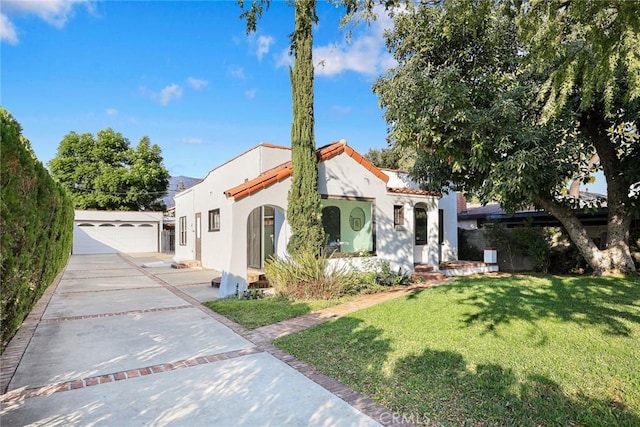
[73,222,158,254]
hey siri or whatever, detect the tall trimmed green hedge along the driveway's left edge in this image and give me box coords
[0,107,73,351]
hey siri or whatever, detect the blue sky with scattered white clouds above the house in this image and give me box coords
[0,0,393,177]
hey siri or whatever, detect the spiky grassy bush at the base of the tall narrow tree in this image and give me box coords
[265,251,358,300]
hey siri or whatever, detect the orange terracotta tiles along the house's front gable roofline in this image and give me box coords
[224,140,389,201]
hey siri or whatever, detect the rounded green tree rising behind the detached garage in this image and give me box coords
[49,128,169,211]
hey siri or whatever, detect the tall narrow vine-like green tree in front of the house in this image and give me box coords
[287,0,324,254]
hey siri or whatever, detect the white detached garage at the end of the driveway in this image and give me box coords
[73,211,162,255]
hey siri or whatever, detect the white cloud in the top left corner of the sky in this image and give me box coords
[0,0,94,44]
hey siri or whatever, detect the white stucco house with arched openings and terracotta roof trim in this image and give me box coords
[175,140,458,296]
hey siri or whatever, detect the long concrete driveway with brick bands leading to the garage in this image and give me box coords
[0,255,394,426]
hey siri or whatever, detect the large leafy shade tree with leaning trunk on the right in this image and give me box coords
[374,0,640,273]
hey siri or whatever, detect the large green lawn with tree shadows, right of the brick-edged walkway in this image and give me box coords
[275,276,640,426]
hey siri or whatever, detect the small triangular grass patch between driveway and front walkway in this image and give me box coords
[204,297,352,329]
